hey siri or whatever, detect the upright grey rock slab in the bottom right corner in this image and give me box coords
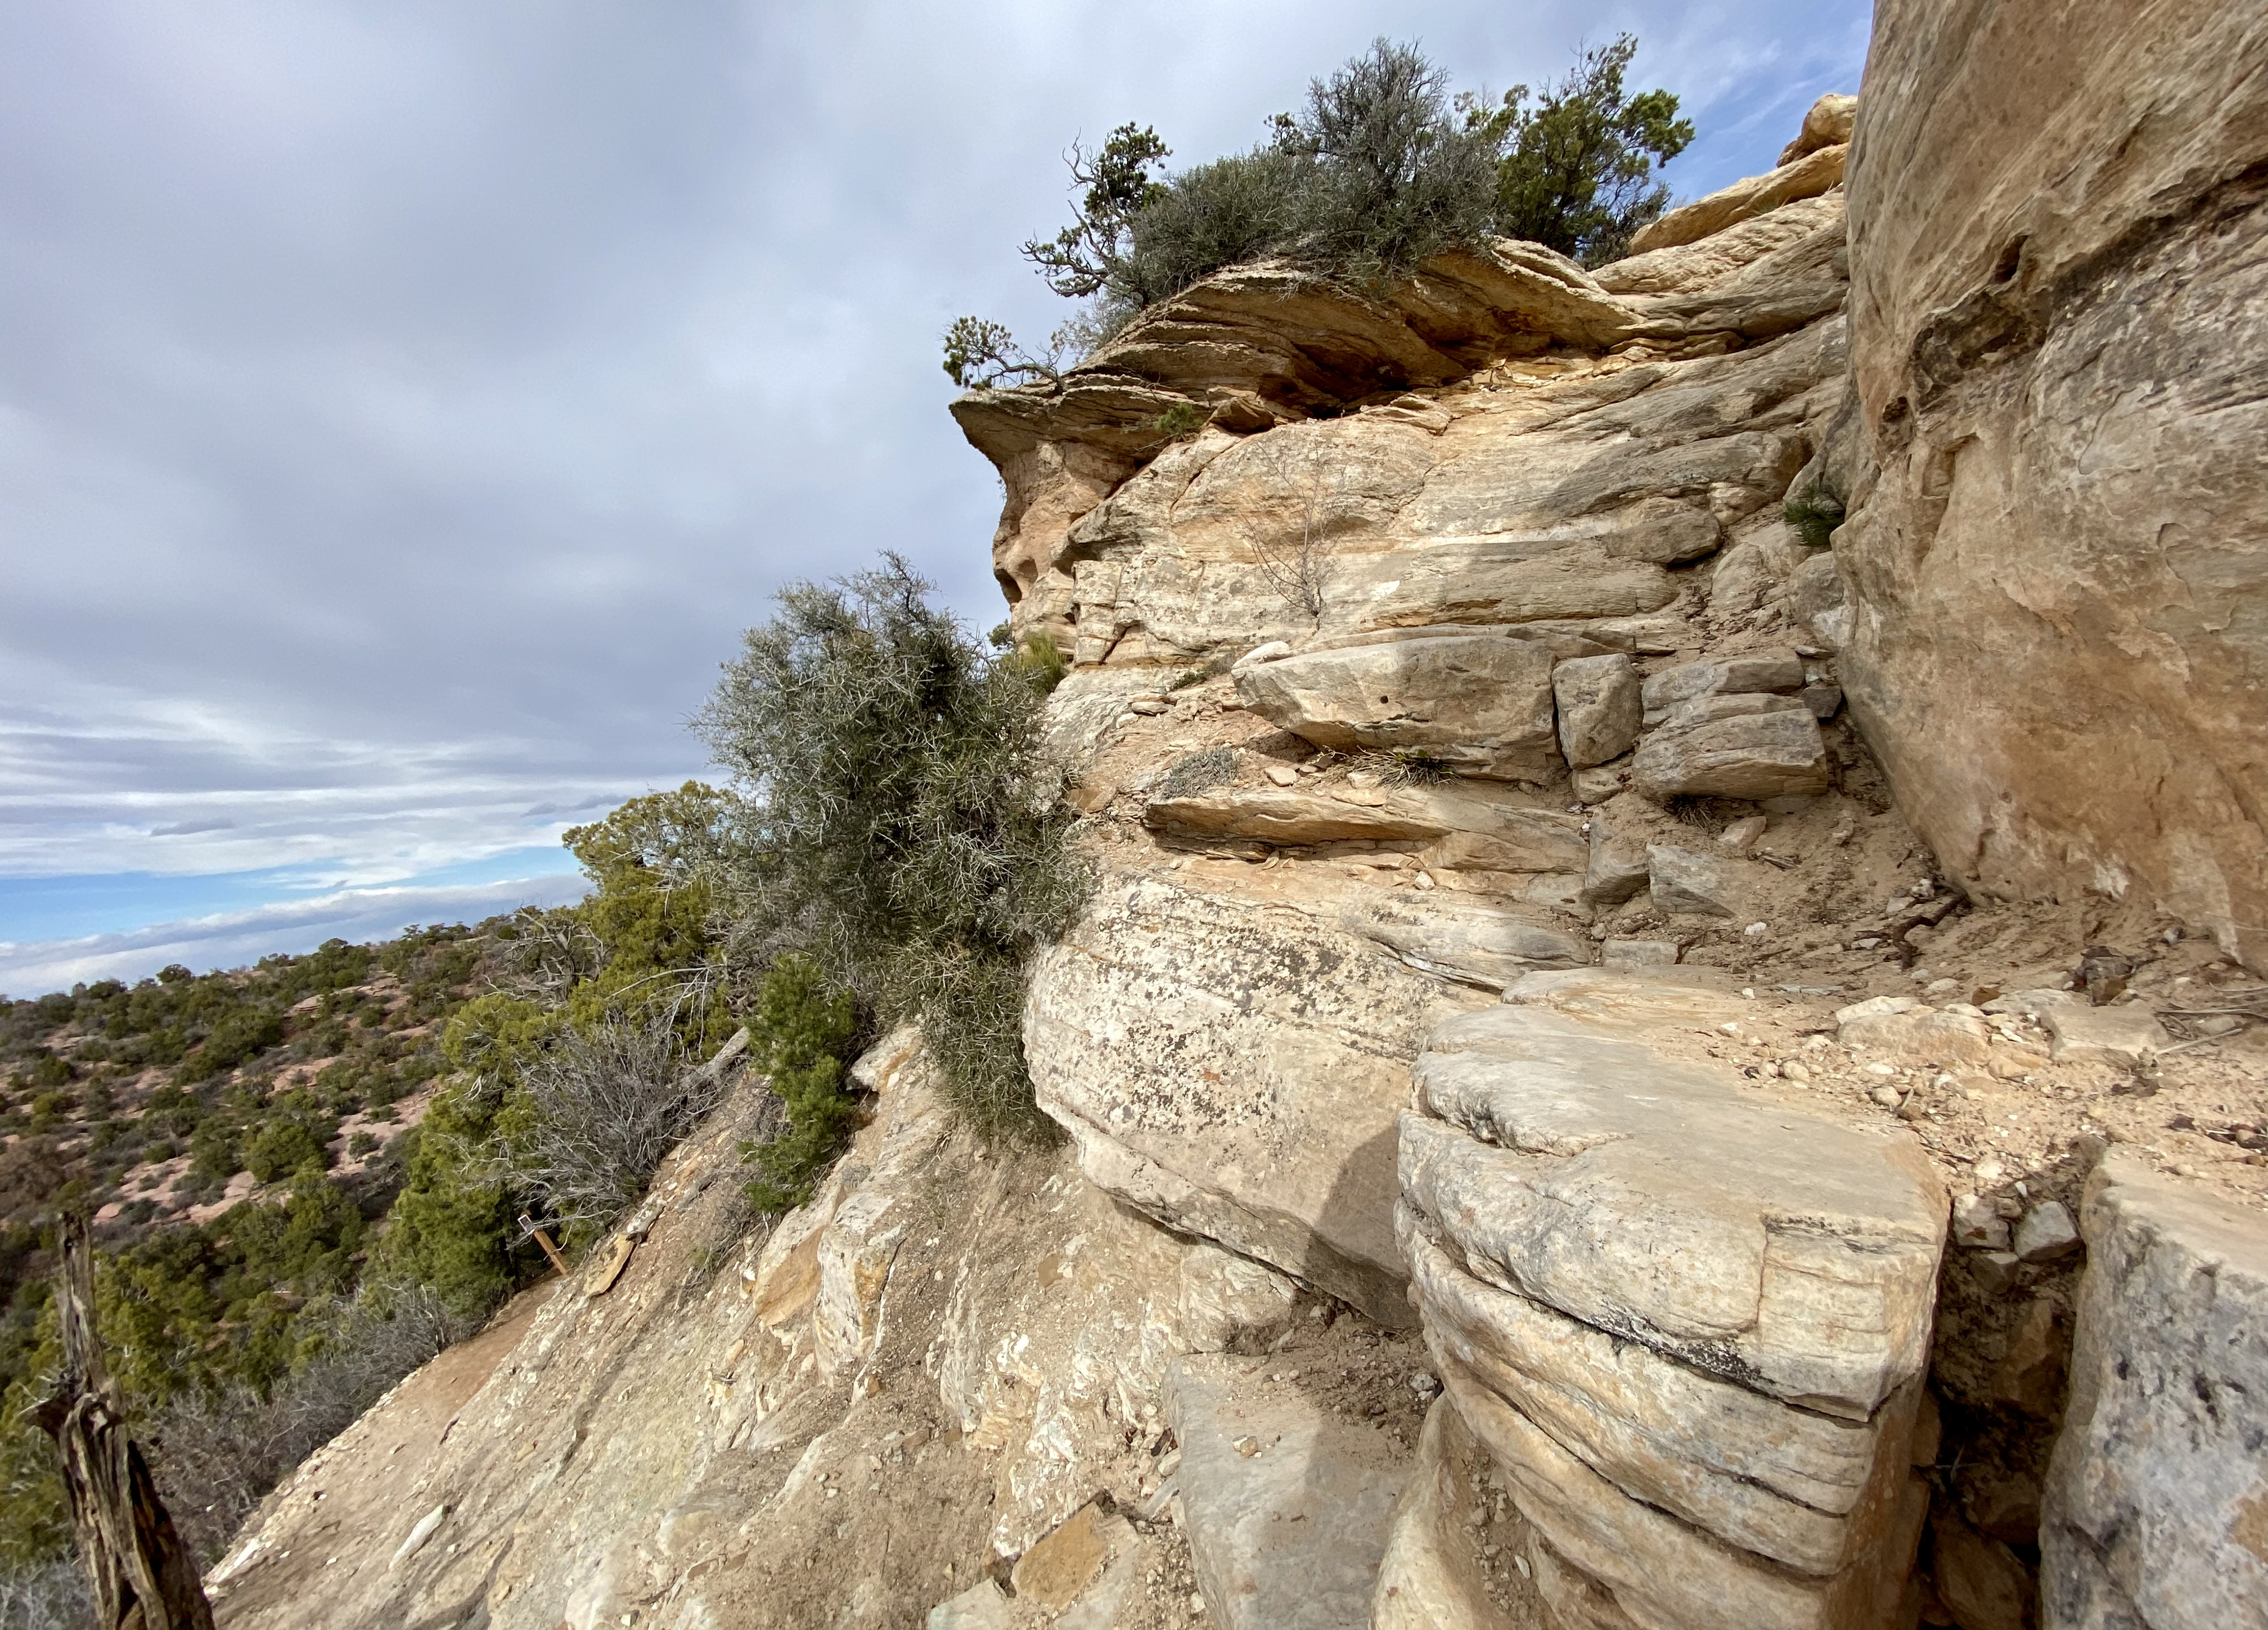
[2039,1150,2268,1630]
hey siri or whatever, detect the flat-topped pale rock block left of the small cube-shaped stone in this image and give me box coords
[1236,637,1558,780]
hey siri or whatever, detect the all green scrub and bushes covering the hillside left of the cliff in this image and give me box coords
[0,558,1084,1626]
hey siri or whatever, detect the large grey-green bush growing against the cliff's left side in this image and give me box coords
[696,555,1086,1131]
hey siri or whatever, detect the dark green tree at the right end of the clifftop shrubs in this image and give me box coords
[1465,34,1694,265]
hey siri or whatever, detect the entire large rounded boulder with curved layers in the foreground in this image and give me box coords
[1397,972,1946,1630]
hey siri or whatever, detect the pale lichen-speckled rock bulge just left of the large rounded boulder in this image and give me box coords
[1025,868,1492,1324]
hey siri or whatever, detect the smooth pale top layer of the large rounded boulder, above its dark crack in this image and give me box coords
[1400,993,1946,1419]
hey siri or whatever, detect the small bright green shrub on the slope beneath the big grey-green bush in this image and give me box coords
[741,954,857,1213]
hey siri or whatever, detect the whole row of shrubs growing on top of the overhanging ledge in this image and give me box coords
[946,34,1694,388]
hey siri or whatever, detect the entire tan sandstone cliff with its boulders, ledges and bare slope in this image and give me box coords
[215,0,2268,1630]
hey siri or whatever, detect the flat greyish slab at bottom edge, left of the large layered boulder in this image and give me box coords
[1166,1358,1408,1630]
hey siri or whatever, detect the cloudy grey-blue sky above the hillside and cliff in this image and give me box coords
[0,0,1866,995]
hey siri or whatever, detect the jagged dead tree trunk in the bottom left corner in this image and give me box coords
[32,1217,213,1630]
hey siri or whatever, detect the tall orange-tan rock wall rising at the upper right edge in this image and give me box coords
[1819,0,2268,968]
